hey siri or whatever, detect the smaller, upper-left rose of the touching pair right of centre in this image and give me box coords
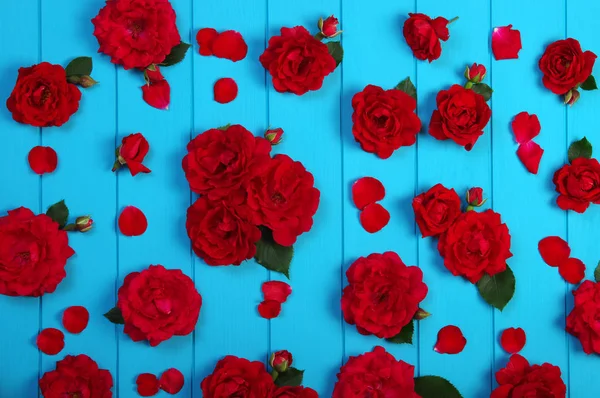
[413,184,461,238]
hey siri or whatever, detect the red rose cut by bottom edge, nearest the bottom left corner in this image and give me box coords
[40,354,113,398]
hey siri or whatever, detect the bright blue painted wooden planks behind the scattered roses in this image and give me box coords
[0,0,600,398]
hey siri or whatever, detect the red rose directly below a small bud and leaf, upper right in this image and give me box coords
[429,84,492,151]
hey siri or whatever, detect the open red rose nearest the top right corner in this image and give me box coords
[539,39,596,94]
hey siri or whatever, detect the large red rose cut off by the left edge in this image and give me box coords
[0,207,75,297]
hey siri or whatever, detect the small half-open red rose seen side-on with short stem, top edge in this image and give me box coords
[403,13,450,62]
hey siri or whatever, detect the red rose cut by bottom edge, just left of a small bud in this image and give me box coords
[200,355,275,398]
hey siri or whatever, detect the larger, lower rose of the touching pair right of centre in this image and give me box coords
[438,210,512,283]
